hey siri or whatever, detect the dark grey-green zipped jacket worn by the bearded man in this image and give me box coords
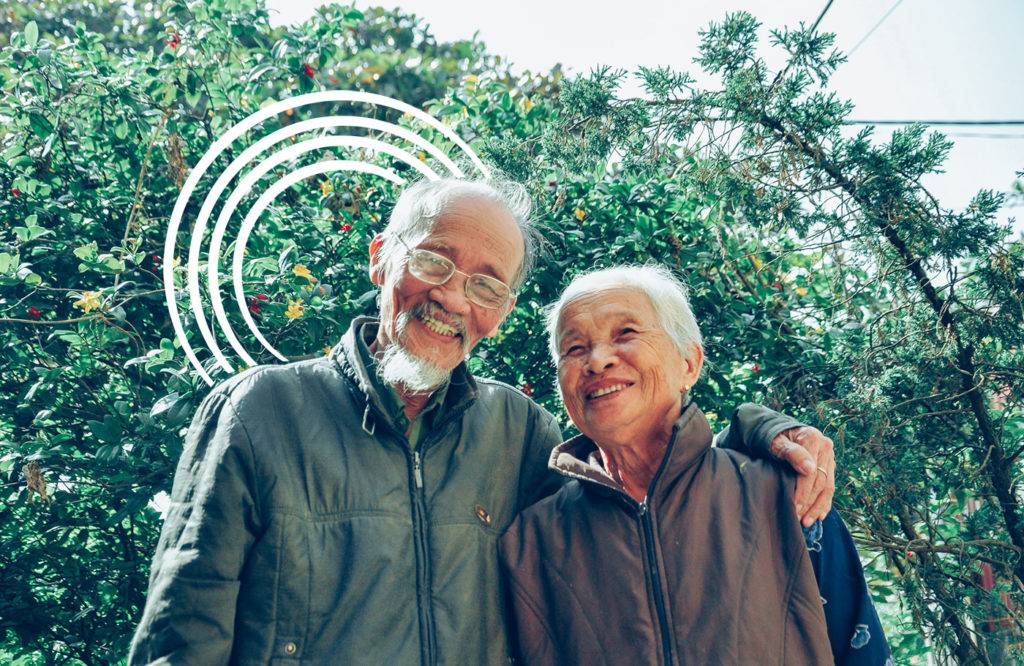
[129,318,797,666]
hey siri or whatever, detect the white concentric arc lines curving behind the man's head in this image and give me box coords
[163,90,488,386]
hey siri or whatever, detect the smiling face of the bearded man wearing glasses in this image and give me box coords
[371,198,523,372]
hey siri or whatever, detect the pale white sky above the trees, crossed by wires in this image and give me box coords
[267,0,1024,232]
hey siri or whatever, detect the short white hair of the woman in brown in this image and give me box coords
[545,264,703,365]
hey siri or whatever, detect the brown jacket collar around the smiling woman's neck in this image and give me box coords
[548,403,712,502]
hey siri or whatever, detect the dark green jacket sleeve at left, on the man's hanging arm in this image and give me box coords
[128,391,258,664]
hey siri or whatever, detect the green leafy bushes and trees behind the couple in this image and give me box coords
[0,0,1024,664]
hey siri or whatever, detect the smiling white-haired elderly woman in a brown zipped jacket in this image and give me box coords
[501,266,889,665]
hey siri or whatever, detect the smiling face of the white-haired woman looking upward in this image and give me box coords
[557,288,703,447]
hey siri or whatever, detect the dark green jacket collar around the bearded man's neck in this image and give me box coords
[329,317,479,432]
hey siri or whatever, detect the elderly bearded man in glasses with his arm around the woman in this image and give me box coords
[130,174,834,664]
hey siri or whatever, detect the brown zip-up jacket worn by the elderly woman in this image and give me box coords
[501,404,833,665]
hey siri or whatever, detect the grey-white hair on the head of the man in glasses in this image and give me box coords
[378,178,540,292]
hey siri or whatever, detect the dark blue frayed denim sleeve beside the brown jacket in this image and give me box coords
[804,510,893,666]
